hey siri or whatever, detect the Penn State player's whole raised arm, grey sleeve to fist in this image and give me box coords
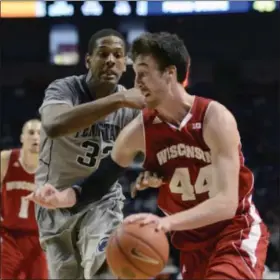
[41,79,144,138]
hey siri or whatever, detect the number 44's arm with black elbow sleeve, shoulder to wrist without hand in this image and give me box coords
[74,112,145,205]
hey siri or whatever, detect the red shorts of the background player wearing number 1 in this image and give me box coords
[1,232,48,279]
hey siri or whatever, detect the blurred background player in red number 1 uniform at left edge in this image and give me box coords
[0,119,48,279]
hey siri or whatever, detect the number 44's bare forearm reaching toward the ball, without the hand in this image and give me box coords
[165,194,237,231]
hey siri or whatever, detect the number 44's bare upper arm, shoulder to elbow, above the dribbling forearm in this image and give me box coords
[203,102,240,216]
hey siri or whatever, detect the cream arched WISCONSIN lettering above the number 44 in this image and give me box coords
[157,143,211,165]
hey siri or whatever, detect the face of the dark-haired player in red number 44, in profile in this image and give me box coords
[134,55,170,108]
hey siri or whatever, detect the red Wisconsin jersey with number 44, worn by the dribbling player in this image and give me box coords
[143,96,260,250]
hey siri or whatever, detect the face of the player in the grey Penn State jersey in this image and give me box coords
[86,36,126,84]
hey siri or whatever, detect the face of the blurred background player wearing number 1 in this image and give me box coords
[21,121,41,153]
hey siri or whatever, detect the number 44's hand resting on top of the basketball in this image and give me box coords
[124,213,171,232]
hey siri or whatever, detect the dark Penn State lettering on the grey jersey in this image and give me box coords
[75,123,121,141]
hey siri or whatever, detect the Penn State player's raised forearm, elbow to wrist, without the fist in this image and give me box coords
[44,92,123,138]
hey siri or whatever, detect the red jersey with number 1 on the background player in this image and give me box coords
[1,149,38,233]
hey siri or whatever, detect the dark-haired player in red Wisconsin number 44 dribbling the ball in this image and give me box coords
[27,33,268,279]
